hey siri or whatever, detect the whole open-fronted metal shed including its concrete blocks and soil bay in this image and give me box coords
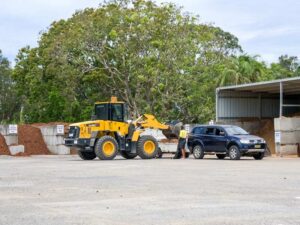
[216,77,300,156]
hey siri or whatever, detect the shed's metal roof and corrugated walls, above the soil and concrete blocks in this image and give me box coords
[216,77,300,122]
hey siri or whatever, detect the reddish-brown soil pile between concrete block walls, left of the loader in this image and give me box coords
[18,125,50,155]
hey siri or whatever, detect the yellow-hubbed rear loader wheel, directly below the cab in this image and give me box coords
[95,135,119,160]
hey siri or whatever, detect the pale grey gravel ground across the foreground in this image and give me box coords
[0,156,300,225]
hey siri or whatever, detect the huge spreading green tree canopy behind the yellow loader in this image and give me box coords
[13,0,295,122]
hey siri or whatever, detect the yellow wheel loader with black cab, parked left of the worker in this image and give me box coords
[65,97,176,160]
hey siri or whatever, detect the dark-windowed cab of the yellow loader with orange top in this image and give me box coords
[93,97,128,122]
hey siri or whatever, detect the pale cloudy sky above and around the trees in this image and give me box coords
[0,0,300,62]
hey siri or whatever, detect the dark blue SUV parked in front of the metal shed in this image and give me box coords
[187,125,266,160]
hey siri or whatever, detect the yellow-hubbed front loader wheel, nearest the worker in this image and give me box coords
[137,135,158,159]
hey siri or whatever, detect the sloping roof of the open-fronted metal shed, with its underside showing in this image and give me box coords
[217,77,300,95]
